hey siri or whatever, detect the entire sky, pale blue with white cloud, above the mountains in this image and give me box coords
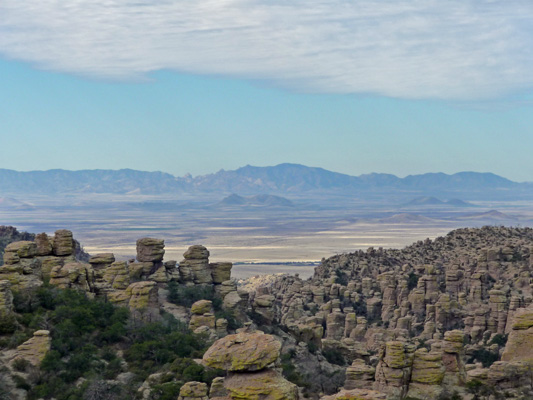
[0,0,533,181]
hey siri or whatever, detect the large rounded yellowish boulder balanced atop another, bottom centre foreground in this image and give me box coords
[203,332,281,371]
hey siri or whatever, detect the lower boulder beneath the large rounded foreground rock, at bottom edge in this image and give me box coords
[224,369,298,400]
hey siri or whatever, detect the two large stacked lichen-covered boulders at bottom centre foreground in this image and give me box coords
[203,331,298,400]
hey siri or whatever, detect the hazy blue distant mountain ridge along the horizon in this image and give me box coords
[0,163,533,196]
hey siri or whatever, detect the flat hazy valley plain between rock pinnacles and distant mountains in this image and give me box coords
[0,188,533,278]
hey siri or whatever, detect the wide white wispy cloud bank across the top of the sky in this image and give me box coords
[0,0,533,99]
